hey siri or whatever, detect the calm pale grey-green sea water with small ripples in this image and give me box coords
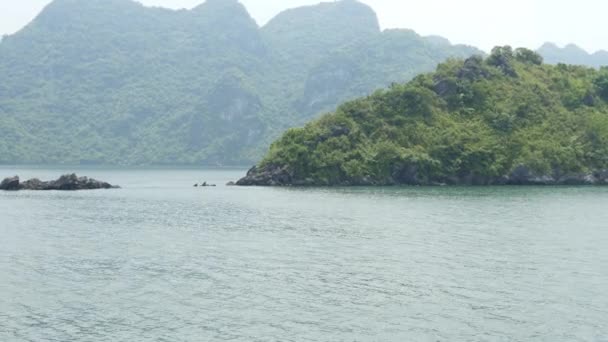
[0,167,608,342]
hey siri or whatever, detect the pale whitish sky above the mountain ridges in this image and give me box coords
[0,0,608,52]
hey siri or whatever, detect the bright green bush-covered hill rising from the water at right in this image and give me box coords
[241,47,608,185]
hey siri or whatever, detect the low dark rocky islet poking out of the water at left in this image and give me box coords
[0,174,119,191]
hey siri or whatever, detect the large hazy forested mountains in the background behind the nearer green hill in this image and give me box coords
[0,0,478,165]
